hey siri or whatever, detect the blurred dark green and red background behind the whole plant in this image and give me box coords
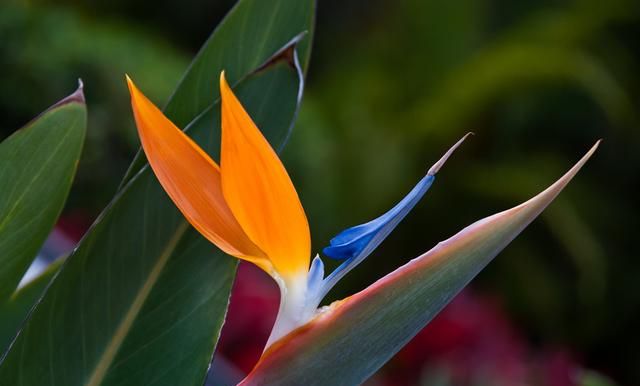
[0,0,640,386]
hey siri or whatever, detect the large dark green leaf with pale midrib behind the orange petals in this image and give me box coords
[0,8,313,386]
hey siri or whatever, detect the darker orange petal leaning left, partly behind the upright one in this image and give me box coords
[127,76,272,272]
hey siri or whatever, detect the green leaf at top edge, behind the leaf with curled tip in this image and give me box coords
[121,0,315,186]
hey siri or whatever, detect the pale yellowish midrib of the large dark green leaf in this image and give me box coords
[85,221,189,386]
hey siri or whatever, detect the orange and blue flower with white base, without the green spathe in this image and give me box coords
[127,73,470,347]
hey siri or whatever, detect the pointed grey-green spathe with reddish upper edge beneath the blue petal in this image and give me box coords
[240,144,598,386]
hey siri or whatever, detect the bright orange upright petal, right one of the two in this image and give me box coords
[220,73,311,276]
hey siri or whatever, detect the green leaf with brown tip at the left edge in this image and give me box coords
[0,87,87,302]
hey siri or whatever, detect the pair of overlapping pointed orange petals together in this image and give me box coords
[127,74,310,278]
